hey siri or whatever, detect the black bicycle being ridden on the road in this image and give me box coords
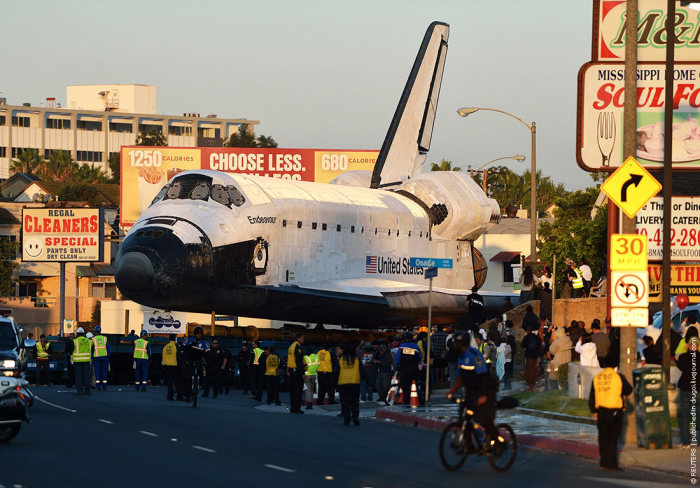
[440,399,518,472]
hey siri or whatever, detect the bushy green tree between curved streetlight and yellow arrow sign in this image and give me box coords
[537,187,608,294]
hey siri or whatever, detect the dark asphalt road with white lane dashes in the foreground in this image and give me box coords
[0,387,684,488]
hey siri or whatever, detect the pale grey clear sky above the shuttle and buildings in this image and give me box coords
[0,0,593,190]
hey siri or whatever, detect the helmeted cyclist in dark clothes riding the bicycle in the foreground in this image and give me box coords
[445,332,503,449]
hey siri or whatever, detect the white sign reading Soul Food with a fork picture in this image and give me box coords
[576,62,700,171]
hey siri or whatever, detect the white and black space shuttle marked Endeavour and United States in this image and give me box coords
[115,22,500,328]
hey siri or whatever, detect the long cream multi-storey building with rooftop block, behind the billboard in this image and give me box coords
[0,85,260,179]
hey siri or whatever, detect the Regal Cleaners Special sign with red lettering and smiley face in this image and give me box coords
[21,207,104,262]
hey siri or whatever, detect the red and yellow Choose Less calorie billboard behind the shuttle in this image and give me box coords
[120,146,379,226]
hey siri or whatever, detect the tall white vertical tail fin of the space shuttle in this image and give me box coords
[371,22,450,188]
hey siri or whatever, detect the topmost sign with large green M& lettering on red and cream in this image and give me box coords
[593,0,700,63]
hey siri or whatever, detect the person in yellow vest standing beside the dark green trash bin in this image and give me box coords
[588,358,632,471]
